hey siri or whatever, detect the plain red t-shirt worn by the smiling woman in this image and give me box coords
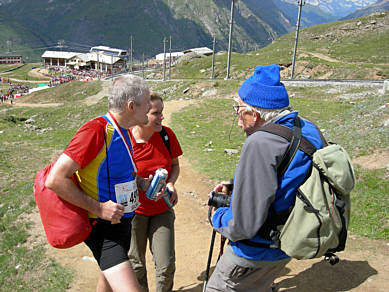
[131,126,182,215]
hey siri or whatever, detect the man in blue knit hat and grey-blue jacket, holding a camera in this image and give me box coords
[206,65,322,292]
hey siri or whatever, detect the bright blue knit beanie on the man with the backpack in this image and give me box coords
[238,65,289,109]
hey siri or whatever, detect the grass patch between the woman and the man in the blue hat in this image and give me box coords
[172,99,244,180]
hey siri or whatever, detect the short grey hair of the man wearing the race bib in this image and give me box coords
[108,75,150,113]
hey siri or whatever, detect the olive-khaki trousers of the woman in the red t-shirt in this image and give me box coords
[129,209,176,292]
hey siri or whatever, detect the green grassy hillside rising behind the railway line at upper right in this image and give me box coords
[172,12,389,79]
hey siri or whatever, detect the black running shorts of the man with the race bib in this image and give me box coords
[85,218,132,271]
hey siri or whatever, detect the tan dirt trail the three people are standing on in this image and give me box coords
[29,101,389,292]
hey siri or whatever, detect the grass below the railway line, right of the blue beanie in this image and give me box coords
[289,87,389,157]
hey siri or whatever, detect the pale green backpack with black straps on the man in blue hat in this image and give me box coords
[245,117,355,264]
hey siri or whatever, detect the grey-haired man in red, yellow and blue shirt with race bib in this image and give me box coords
[46,75,161,291]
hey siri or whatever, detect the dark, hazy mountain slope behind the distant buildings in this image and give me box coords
[0,0,294,57]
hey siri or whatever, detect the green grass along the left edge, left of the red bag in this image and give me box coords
[0,120,71,291]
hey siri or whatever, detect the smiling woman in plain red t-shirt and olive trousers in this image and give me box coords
[129,92,182,291]
